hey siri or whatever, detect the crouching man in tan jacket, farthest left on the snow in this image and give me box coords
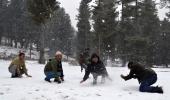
[8,53,32,78]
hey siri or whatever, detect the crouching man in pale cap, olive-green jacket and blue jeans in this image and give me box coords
[44,51,64,84]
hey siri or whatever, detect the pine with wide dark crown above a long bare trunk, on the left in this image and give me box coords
[27,0,59,64]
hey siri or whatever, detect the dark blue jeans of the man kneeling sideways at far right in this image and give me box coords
[139,75,157,92]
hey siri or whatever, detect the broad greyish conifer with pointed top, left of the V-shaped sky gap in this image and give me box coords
[46,8,75,57]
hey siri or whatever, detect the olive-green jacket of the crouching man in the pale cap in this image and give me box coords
[44,58,59,73]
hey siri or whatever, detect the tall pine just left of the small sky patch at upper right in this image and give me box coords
[140,0,160,66]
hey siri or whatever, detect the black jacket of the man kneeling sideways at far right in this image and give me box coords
[124,63,157,83]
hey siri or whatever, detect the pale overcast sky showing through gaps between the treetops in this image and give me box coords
[58,0,167,29]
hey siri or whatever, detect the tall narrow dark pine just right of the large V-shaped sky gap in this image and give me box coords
[77,0,92,53]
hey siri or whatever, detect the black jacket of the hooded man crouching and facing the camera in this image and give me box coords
[83,61,108,81]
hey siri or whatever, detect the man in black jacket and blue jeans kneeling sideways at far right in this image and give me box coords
[121,62,163,93]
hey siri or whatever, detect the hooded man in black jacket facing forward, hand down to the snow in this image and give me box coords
[80,53,108,85]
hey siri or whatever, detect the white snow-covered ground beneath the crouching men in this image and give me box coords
[0,60,170,100]
